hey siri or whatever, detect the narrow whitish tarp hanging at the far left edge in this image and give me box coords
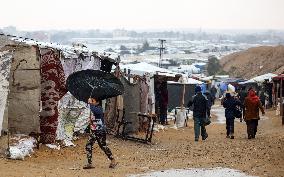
[0,51,12,136]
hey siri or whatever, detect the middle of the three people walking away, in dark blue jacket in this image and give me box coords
[223,92,242,139]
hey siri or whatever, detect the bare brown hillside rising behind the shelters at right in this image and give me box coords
[220,45,284,79]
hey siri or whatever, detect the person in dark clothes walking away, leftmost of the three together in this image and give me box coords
[187,86,209,141]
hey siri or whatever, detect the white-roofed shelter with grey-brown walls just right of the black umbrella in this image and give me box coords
[118,62,180,133]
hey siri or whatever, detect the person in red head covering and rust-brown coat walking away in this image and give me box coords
[244,89,265,139]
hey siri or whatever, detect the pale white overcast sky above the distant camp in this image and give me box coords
[0,0,284,30]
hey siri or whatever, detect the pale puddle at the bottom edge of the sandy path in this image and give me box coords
[129,167,255,177]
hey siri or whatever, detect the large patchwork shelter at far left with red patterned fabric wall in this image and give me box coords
[0,35,116,143]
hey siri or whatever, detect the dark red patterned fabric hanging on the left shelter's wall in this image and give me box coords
[40,48,67,143]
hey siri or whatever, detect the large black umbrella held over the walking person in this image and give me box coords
[66,69,124,103]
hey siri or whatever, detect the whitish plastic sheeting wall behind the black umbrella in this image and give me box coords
[56,54,100,140]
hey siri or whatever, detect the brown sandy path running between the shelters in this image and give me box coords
[0,106,284,177]
